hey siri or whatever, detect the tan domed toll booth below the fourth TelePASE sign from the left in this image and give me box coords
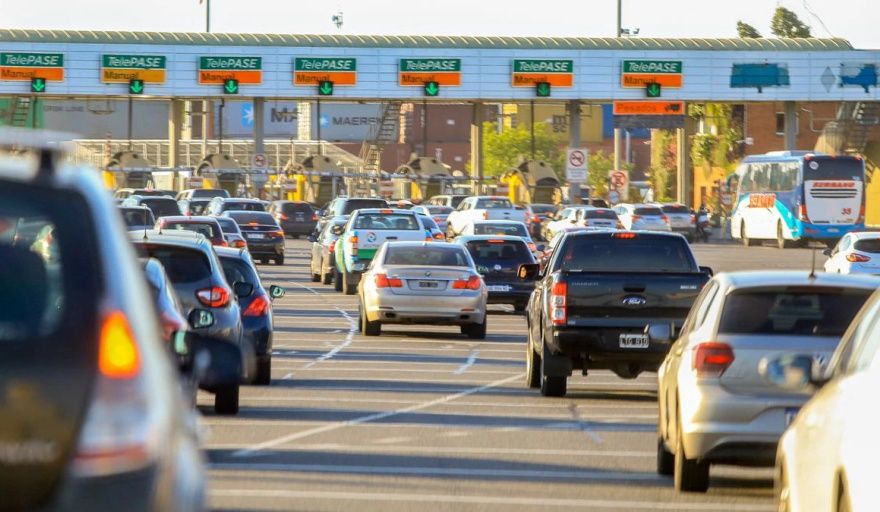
[282,155,348,206]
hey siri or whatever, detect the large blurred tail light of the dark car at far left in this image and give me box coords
[72,311,162,476]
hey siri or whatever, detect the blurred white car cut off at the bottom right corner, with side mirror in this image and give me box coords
[764,286,880,511]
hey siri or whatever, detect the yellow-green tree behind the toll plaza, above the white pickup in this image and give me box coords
[483,123,566,179]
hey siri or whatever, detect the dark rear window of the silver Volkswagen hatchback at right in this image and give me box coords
[718,286,870,336]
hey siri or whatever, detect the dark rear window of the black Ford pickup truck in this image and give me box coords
[555,235,696,272]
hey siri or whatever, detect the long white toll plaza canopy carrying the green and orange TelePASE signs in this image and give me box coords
[0,30,880,101]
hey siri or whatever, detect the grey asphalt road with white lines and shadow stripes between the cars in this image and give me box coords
[199,241,823,511]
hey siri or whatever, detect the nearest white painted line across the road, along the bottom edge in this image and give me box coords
[208,489,773,512]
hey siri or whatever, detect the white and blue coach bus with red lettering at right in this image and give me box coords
[730,151,865,248]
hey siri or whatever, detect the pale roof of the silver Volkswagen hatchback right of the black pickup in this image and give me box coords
[716,270,880,290]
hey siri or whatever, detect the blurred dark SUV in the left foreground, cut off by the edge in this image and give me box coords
[0,130,206,511]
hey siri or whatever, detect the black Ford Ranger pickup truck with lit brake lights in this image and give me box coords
[519,231,712,396]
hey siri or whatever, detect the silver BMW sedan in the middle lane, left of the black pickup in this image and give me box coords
[358,242,496,339]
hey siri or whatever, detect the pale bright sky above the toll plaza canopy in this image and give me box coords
[0,0,880,49]
